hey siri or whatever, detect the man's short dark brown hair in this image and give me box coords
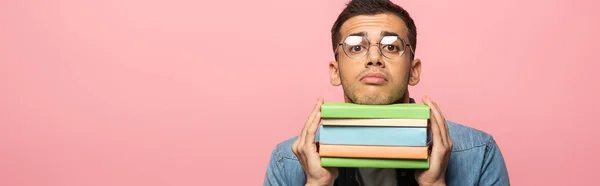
[331,0,417,59]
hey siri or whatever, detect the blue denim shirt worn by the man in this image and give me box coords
[263,121,510,186]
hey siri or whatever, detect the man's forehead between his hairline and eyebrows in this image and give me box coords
[340,13,408,40]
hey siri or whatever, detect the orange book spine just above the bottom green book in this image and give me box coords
[319,144,429,159]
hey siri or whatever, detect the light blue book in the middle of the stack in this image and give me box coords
[315,125,429,146]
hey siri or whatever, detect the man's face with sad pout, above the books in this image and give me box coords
[329,14,421,104]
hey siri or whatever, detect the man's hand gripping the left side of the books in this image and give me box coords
[292,98,338,186]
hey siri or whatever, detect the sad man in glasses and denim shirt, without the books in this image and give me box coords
[264,0,510,186]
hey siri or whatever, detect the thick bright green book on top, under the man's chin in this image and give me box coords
[321,102,430,119]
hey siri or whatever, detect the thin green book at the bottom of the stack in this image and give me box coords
[321,157,429,169]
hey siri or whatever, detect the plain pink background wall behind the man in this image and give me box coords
[0,0,600,186]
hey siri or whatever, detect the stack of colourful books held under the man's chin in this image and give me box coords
[315,102,431,169]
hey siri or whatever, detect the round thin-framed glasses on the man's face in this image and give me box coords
[335,36,414,60]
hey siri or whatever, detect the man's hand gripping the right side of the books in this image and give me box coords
[415,97,452,186]
